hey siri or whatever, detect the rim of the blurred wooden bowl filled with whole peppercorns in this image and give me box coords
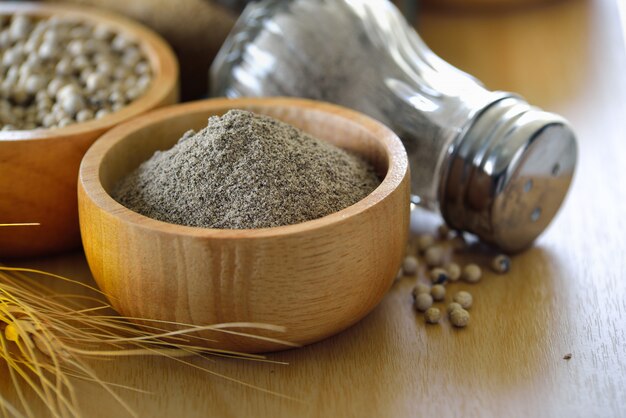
[0,2,179,143]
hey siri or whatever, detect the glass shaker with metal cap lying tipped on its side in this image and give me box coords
[210,0,577,252]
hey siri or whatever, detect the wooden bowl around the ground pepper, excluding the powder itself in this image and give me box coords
[78,98,409,352]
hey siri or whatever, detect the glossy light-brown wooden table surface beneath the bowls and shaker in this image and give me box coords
[0,0,626,418]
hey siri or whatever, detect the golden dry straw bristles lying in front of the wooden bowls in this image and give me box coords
[0,250,295,417]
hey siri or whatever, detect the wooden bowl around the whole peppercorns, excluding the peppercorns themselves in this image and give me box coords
[0,2,178,257]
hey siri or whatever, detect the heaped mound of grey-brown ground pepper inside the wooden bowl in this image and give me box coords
[113,110,380,229]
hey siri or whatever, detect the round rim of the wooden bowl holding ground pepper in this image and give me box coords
[79,97,409,239]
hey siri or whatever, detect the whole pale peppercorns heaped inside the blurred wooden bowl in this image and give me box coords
[0,14,152,130]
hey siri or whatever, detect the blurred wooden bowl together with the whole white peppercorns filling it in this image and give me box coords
[0,2,178,258]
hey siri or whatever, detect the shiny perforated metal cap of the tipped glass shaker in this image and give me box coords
[439,96,577,252]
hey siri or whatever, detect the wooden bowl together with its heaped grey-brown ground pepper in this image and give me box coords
[78,98,410,352]
